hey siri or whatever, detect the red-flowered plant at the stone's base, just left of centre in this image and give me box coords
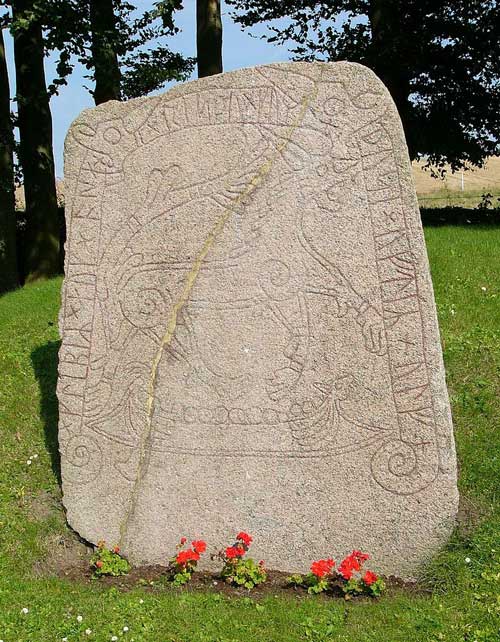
[219,531,267,589]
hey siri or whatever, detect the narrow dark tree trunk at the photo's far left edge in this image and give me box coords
[0,29,19,294]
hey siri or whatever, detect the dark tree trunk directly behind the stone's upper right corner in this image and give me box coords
[368,0,414,156]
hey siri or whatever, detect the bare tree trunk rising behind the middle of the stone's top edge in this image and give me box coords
[196,0,222,78]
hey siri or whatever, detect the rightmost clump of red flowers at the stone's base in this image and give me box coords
[288,551,385,599]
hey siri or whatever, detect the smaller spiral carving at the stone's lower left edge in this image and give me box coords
[62,435,102,484]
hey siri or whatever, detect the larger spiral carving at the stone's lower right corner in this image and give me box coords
[371,439,438,495]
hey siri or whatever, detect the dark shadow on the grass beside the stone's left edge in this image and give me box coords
[31,341,61,485]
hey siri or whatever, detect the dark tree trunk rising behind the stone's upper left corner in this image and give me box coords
[90,0,121,105]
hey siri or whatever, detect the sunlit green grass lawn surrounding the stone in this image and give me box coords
[0,225,500,642]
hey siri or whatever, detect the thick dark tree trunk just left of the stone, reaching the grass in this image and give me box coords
[12,0,61,281]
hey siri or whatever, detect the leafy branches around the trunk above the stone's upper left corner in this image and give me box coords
[38,0,194,103]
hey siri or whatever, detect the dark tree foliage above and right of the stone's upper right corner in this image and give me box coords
[227,0,500,169]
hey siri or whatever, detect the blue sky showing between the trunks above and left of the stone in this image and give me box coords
[5,0,289,178]
